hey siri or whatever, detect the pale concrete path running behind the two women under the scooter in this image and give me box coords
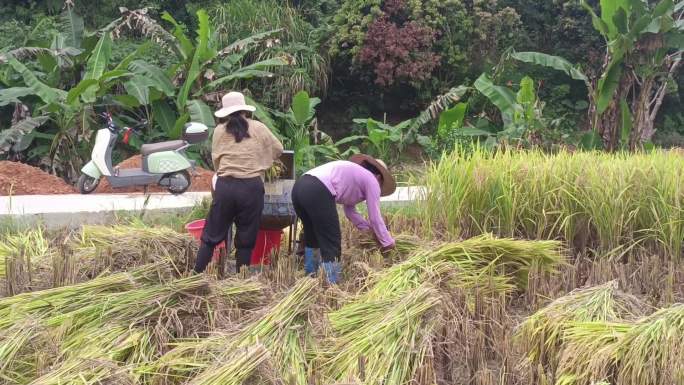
[0,187,424,228]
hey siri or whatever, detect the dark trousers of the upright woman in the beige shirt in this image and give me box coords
[195,177,264,273]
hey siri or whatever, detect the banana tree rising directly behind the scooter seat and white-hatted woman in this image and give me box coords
[112,8,288,139]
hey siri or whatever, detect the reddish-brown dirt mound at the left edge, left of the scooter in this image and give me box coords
[0,160,75,196]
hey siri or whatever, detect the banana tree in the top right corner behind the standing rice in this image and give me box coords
[512,0,684,150]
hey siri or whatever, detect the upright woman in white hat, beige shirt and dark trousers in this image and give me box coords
[195,92,283,272]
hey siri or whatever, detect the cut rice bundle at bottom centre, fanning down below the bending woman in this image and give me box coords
[321,284,441,385]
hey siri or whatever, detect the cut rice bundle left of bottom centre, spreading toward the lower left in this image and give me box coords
[151,278,318,385]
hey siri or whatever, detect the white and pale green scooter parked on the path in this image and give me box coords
[78,113,209,194]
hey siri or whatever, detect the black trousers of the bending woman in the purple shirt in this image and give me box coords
[292,175,342,262]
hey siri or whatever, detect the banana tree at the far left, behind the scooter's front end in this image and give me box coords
[0,33,133,178]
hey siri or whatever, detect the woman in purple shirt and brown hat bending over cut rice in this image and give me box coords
[292,154,396,283]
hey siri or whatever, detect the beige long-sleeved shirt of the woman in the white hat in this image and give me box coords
[211,119,283,179]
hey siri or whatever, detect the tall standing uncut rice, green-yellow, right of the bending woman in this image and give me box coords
[422,149,684,259]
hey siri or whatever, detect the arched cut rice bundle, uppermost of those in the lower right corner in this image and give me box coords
[516,281,648,371]
